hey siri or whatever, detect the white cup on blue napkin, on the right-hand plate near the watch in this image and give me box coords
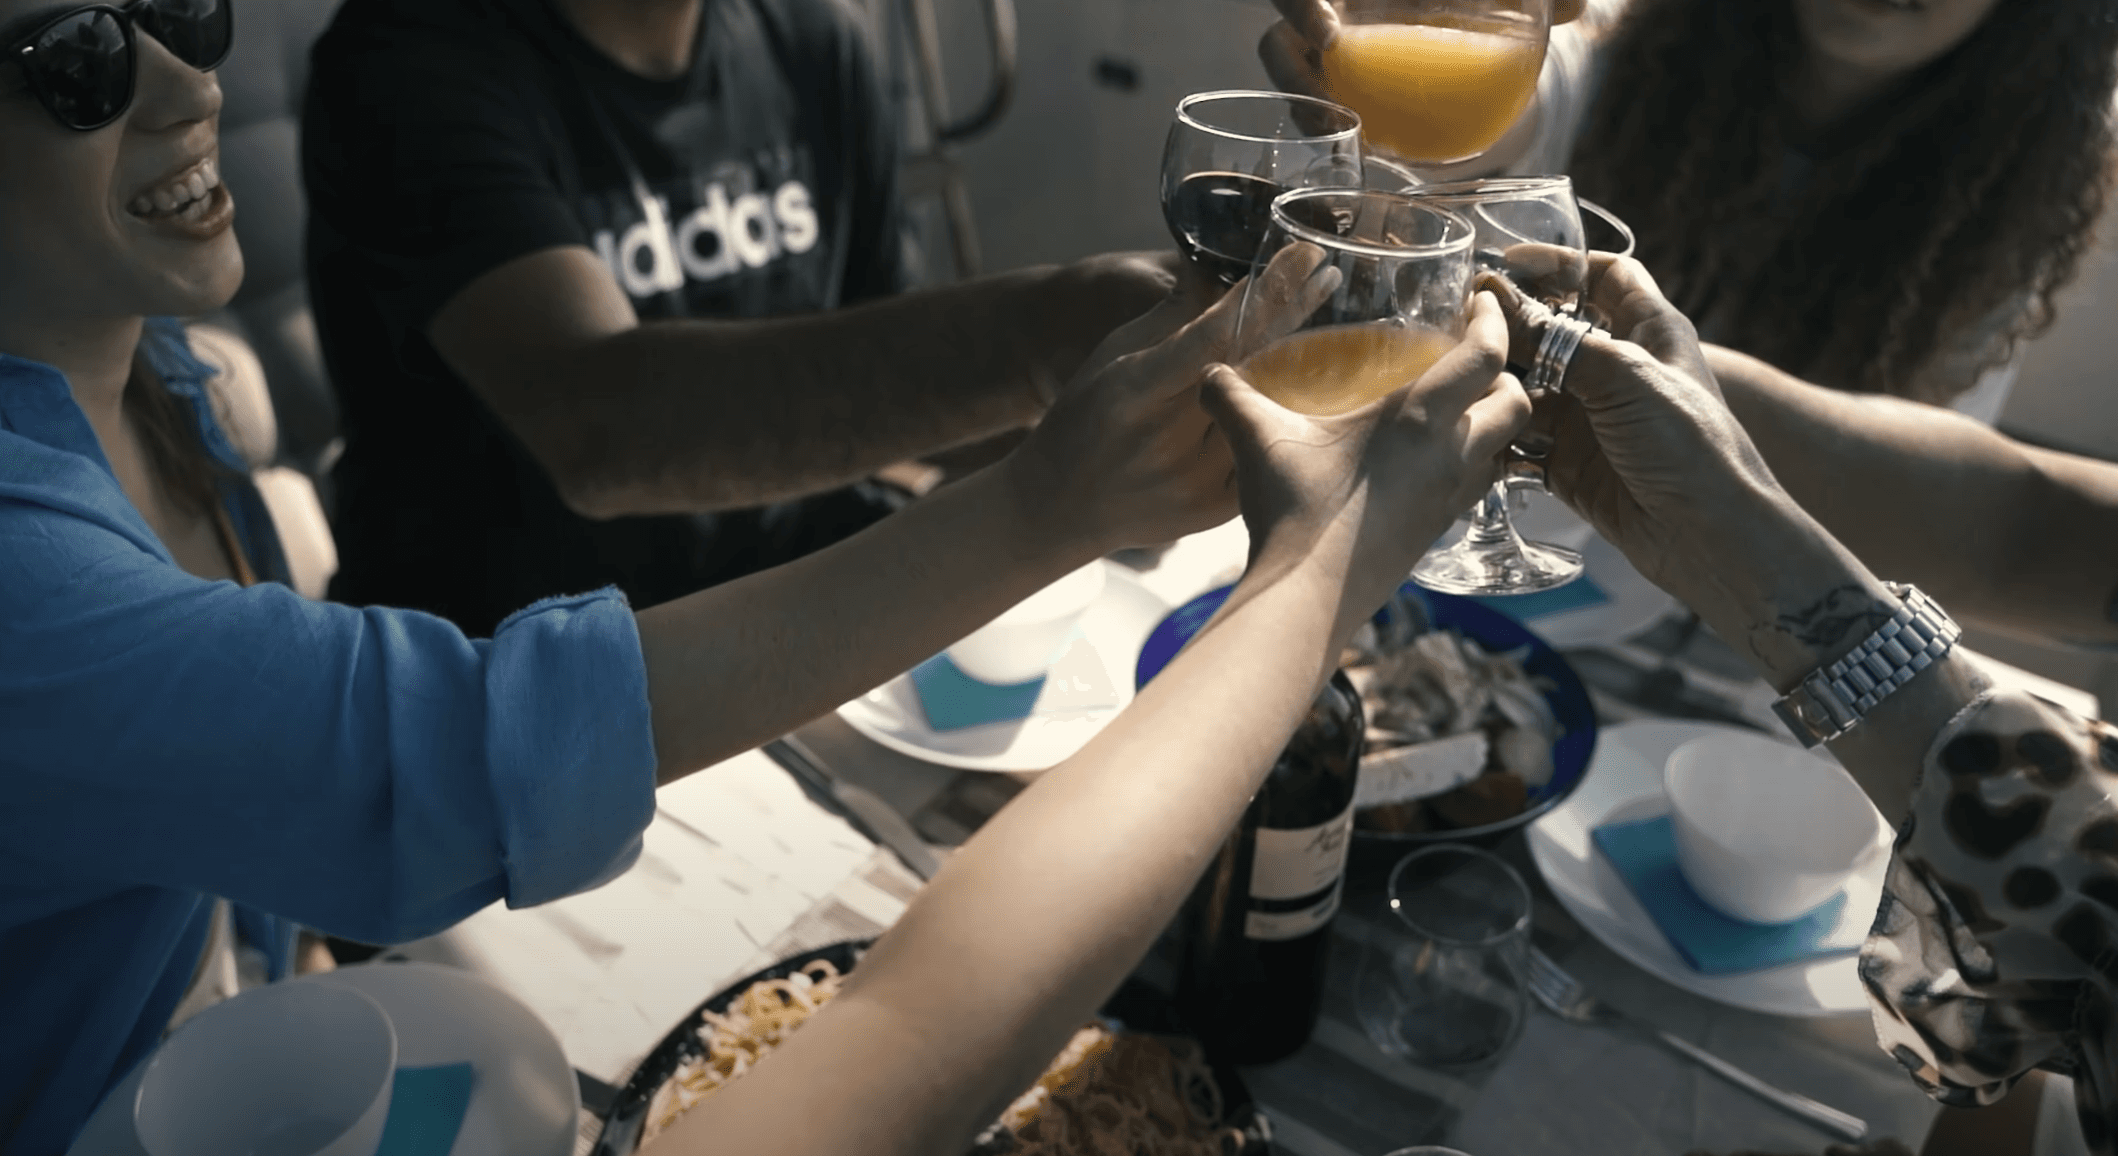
[1663,733,1881,923]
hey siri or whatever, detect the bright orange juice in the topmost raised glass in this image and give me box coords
[1324,23,1544,163]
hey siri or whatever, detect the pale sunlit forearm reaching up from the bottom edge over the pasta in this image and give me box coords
[667,518,1360,1156]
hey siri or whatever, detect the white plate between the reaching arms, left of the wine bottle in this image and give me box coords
[839,565,1173,771]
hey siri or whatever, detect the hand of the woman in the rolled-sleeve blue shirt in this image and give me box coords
[998,246,1336,553]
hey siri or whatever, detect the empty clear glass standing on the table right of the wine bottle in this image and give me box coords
[1353,845,1529,1067]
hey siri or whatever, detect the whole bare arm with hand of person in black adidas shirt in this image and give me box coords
[428,246,1173,517]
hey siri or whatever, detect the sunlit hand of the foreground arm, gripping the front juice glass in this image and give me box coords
[1203,292,1529,601]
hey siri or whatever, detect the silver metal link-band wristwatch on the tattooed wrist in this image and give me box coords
[1773,582,1963,747]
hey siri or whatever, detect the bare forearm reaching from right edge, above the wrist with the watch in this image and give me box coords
[1707,345,2118,642]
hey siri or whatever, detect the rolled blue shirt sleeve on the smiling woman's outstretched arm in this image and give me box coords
[0,499,654,942]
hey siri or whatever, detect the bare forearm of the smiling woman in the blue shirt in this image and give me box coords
[638,466,1101,783]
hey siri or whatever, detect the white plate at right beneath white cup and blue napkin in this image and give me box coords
[1529,722,1891,1016]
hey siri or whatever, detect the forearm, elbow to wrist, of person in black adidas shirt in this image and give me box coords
[540,269,1067,517]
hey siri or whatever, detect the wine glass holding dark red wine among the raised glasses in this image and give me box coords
[1163,91,1362,286]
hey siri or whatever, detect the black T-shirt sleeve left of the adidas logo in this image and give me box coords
[303,4,589,332]
